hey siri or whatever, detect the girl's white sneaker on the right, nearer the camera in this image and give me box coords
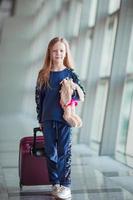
[57,185,71,199]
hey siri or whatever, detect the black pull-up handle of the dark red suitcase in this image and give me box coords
[32,127,45,156]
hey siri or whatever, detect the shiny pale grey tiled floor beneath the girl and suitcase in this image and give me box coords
[0,115,133,200]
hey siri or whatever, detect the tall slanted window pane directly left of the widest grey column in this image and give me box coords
[91,15,117,152]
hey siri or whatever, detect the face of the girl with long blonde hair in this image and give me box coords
[51,41,66,64]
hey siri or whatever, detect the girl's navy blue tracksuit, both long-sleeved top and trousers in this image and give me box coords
[35,68,84,186]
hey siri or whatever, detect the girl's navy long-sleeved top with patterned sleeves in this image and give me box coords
[35,68,85,123]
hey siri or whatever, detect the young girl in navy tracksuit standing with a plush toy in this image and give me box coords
[35,37,84,198]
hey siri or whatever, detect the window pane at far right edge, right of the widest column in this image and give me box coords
[116,24,133,157]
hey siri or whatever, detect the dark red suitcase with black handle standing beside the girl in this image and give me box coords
[19,128,50,189]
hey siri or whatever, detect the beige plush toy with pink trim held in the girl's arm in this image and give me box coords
[60,78,84,128]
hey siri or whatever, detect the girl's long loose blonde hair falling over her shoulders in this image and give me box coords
[37,37,74,86]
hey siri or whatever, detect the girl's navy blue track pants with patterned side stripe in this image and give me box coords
[43,120,72,186]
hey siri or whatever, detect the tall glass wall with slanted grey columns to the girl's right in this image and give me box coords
[70,0,133,166]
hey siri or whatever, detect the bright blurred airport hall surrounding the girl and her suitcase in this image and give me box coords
[0,0,133,200]
